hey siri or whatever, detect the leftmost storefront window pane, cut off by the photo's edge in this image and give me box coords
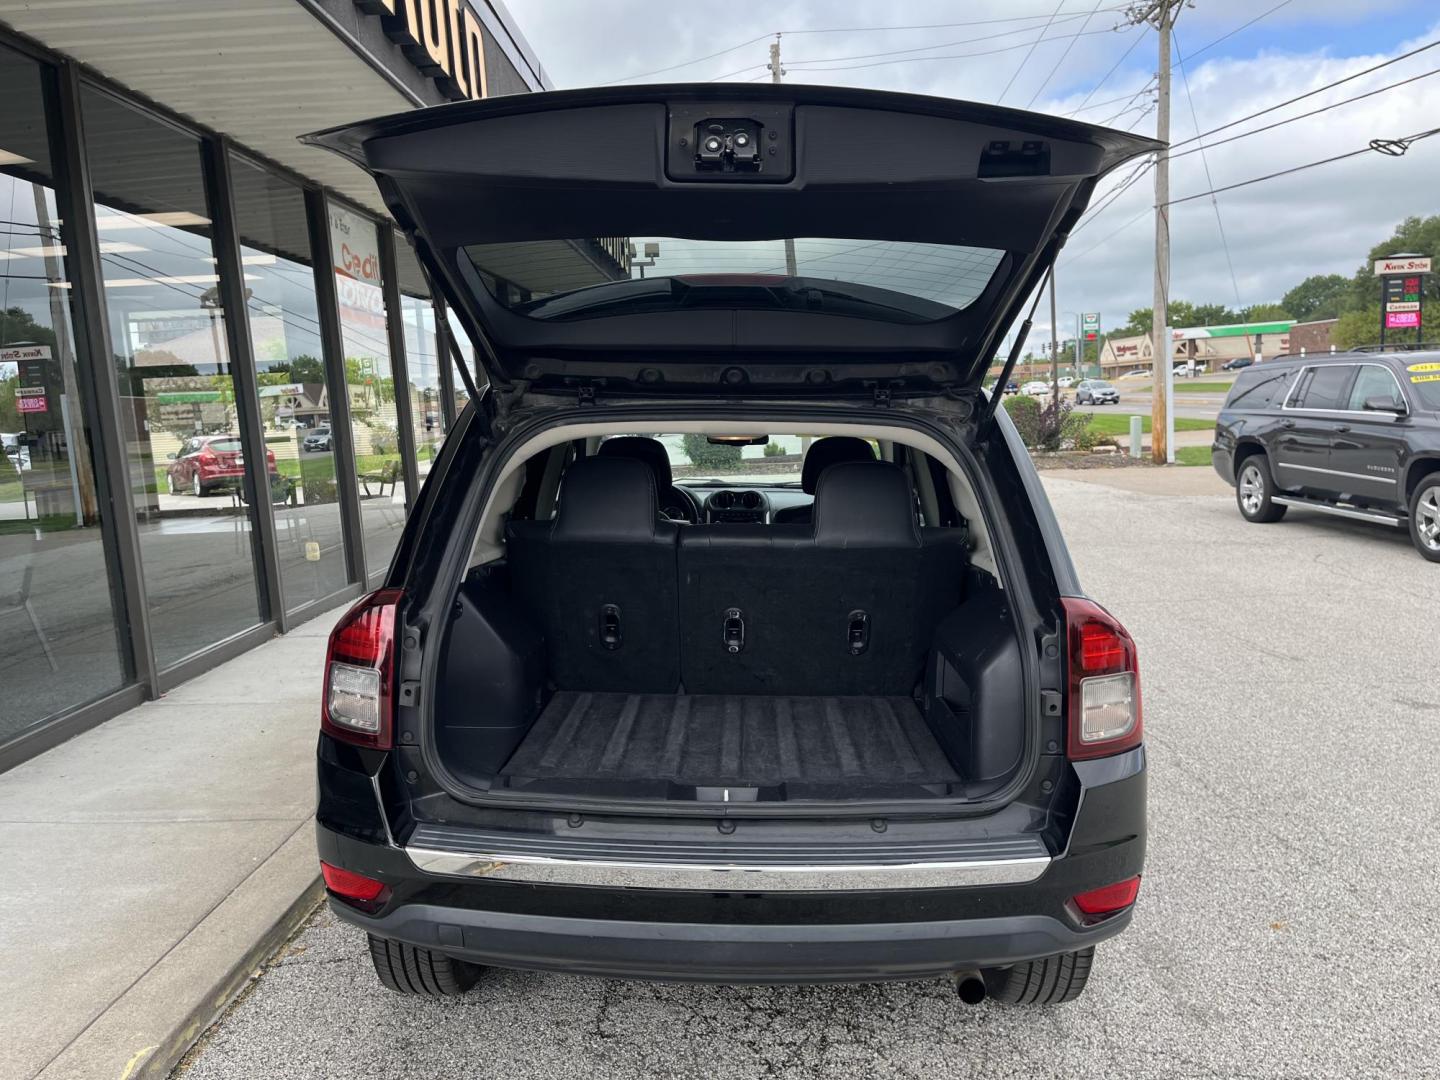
[0,46,127,742]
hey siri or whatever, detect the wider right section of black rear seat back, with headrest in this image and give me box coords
[680,462,963,696]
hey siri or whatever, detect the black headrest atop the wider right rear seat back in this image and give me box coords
[815,461,920,547]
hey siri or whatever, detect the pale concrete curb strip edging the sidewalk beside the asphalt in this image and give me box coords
[39,819,324,1080]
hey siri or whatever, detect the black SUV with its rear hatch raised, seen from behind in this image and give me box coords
[300,85,1158,1002]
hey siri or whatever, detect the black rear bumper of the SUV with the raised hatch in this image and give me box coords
[317,747,1146,982]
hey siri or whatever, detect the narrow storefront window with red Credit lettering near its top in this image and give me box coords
[328,202,405,575]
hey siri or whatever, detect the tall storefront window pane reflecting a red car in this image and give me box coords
[82,86,267,668]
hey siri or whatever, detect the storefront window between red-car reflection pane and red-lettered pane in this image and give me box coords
[230,156,347,611]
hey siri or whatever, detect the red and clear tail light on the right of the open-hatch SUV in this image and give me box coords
[1060,596,1143,760]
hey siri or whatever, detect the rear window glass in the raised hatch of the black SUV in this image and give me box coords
[465,243,1005,323]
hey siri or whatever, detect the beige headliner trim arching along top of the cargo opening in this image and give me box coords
[471,420,999,577]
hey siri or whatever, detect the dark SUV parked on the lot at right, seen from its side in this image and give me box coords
[1214,350,1440,562]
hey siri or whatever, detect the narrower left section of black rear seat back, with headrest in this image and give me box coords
[507,456,680,693]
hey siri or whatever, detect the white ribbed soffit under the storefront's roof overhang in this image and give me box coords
[0,0,415,213]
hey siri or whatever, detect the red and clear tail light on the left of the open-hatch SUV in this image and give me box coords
[320,589,402,750]
